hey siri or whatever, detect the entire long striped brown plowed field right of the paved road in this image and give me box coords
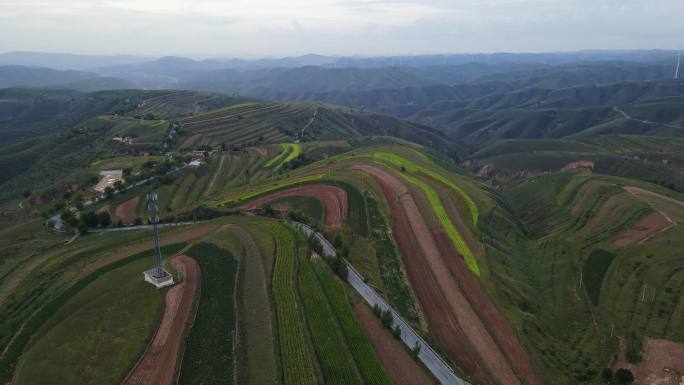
[354,164,543,385]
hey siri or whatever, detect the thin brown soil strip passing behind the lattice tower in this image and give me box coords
[79,223,219,277]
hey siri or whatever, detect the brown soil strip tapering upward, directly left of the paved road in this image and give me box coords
[354,304,433,385]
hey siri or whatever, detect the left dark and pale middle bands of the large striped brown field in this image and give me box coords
[354,164,518,384]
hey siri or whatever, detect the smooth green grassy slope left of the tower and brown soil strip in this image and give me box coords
[14,259,163,385]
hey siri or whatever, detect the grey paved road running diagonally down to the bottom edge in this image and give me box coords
[293,222,470,385]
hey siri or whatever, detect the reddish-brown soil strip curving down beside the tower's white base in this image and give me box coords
[124,255,199,385]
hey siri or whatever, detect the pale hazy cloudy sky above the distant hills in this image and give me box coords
[0,0,684,57]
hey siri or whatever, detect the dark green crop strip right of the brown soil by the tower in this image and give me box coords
[178,243,237,385]
